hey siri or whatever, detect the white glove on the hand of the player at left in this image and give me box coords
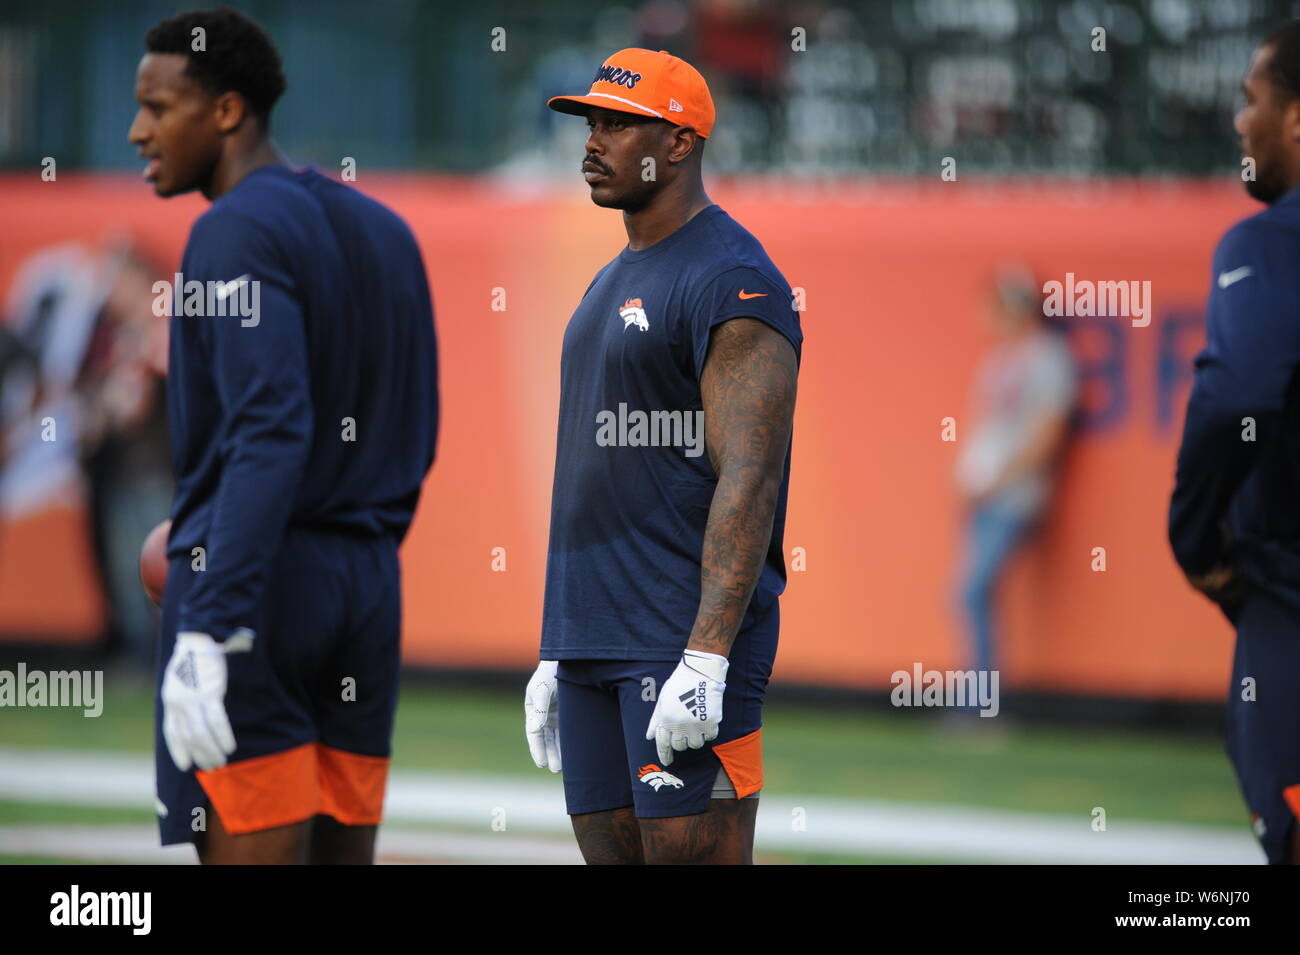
[163,631,235,772]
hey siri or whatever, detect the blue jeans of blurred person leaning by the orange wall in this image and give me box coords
[961,499,1036,711]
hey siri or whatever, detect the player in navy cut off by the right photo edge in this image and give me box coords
[1169,21,1300,863]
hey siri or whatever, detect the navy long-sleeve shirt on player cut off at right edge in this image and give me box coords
[1169,190,1300,599]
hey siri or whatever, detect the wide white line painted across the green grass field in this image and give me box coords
[0,747,1264,865]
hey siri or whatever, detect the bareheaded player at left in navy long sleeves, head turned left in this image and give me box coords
[130,9,438,863]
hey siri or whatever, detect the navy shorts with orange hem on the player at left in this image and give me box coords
[155,528,402,846]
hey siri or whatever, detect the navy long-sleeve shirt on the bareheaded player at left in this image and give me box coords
[166,166,438,639]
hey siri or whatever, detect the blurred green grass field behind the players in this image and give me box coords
[0,674,1245,863]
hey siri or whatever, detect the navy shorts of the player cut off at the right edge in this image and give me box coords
[1227,590,1300,864]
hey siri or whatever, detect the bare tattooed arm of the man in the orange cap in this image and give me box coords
[686,318,798,656]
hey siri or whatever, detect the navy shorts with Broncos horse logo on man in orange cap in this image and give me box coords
[558,605,779,819]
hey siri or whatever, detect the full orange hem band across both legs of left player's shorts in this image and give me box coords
[195,743,390,835]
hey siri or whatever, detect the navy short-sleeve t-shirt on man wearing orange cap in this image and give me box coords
[541,205,803,660]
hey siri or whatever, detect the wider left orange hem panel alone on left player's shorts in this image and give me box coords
[196,743,320,835]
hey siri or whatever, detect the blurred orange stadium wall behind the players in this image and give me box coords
[0,175,1253,699]
